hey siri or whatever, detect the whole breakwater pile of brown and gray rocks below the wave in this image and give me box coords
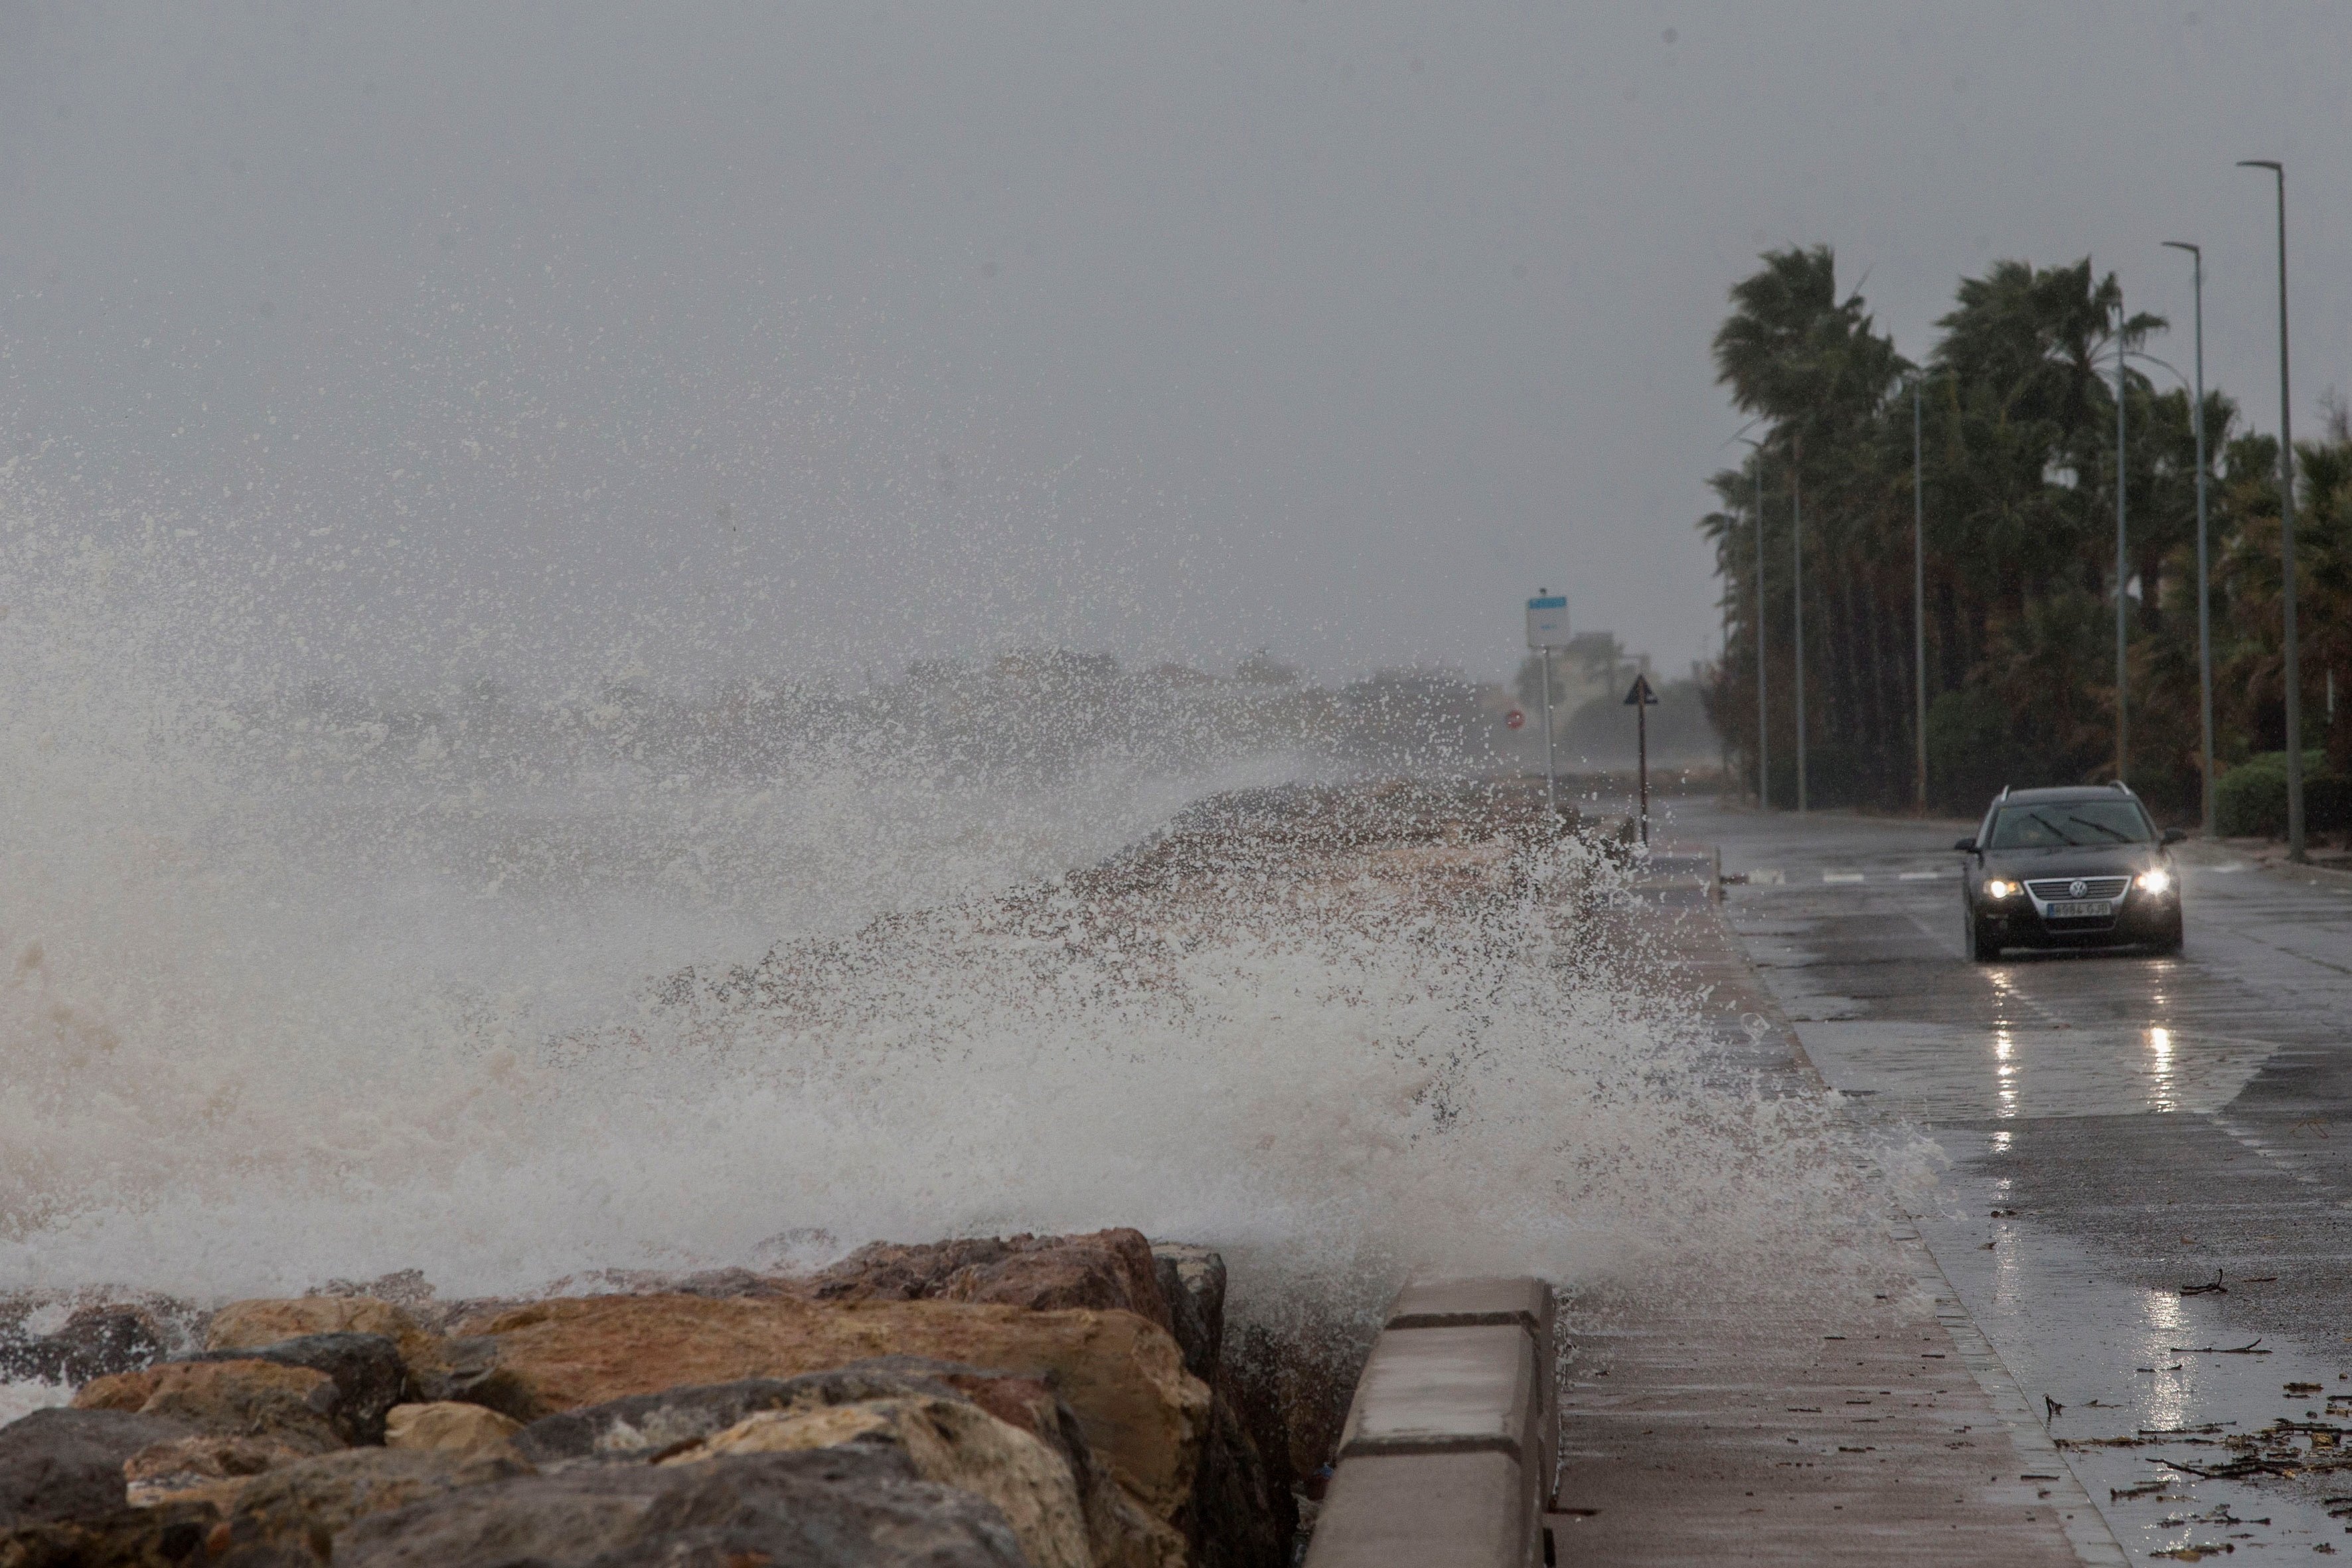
[0,1229,1294,1568]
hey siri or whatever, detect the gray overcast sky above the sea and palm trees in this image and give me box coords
[0,0,2352,674]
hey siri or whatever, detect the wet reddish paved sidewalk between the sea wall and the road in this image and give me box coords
[1550,868,2124,1568]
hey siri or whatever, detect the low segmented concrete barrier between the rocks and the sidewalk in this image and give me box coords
[1305,1279,1559,1568]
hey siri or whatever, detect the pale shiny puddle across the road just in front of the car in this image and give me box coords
[1804,1018,2277,1121]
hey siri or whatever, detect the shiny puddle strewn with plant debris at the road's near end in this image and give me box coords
[1919,1129,2352,1563]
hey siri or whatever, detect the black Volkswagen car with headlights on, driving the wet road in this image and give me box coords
[1952,783,2187,964]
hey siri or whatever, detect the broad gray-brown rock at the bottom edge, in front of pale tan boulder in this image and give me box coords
[334,1446,1023,1568]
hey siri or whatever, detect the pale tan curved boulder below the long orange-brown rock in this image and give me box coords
[661,1396,1093,1568]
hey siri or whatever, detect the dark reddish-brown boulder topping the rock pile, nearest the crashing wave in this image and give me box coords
[807,1229,1169,1328]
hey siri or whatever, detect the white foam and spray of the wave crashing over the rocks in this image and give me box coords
[0,522,1891,1335]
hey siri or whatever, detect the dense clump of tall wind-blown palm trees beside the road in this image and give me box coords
[1701,247,2286,811]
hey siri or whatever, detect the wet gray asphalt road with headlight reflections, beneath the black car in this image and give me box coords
[1672,802,2352,1561]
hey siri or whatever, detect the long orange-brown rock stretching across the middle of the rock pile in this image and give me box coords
[456,1295,1209,1521]
